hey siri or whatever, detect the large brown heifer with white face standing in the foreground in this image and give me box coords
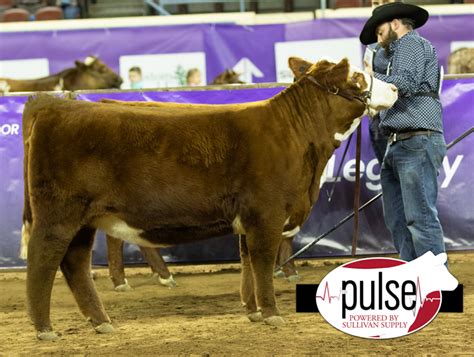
[22,59,397,340]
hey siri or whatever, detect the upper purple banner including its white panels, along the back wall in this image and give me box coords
[0,15,474,85]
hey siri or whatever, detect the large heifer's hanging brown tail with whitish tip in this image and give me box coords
[20,97,42,259]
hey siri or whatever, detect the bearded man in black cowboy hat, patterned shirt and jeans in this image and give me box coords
[360,2,446,261]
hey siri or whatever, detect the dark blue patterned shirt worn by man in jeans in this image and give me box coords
[374,31,443,133]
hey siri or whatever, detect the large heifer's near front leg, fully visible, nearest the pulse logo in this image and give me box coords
[246,225,284,326]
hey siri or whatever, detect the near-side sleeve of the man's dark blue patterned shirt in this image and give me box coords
[374,39,425,97]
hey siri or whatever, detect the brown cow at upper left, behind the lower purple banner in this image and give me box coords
[0,56,122,92]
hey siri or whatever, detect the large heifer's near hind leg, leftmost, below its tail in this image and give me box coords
[26,220,75,340]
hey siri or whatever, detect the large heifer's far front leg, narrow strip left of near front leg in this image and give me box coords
[239,235,263,322]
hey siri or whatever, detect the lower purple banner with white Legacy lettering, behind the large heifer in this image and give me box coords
[0,79,474,266]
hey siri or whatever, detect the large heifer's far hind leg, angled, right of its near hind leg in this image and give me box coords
[61,227,114,333]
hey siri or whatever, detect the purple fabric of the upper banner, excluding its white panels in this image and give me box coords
[0,15,474,82]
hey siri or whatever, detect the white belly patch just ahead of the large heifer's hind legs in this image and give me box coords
[93,216,164,248]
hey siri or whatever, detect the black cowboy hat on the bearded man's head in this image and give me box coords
[359,2,430,45]
